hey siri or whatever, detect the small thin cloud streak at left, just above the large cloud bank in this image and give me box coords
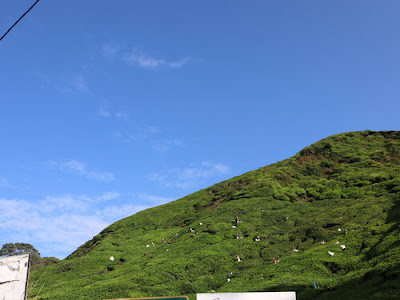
[48,160,115,182]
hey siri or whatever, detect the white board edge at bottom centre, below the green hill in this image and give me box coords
[197,292,296,300]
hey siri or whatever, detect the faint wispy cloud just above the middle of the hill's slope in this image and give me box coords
[148,162,231,189]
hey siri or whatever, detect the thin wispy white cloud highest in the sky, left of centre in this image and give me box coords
[123,51,190,70]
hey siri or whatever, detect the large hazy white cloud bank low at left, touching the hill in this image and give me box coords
[0,192,149,258]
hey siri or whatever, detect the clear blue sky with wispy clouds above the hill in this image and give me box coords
[0,0,400,258]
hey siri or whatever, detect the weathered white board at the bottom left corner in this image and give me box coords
[0,254,29,300]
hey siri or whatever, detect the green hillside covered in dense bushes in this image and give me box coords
[30,131,400,300]
